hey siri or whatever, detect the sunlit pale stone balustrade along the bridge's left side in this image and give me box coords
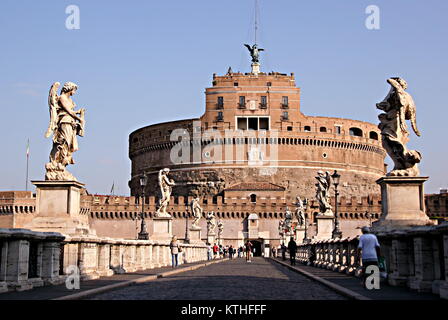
[0,229,207,292]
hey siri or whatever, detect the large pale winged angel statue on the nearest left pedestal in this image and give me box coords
[45,82,85,181]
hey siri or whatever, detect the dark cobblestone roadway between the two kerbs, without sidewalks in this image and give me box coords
[91,258,345,300]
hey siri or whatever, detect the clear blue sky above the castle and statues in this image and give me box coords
[0,0,448,195]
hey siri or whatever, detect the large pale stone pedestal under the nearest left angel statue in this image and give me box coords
[24,181,92,235]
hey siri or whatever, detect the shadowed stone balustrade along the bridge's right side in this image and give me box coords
[297,223,448,299]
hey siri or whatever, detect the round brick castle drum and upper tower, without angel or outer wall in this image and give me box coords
[129,68,386,201]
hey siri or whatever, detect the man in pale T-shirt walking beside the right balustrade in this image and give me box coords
[358,227,381,286]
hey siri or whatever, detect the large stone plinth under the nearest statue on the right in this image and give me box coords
[373,176,434,231]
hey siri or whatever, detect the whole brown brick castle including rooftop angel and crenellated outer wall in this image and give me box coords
[0,45,386,253]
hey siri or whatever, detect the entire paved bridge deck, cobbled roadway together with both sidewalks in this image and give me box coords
[0,257,439,300]
